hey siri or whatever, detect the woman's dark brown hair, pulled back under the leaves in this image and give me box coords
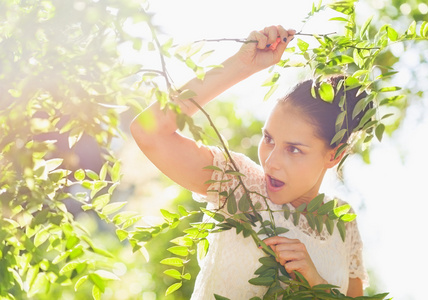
[278,75,371,148]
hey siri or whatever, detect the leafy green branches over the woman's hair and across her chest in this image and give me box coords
[132,0,428,299]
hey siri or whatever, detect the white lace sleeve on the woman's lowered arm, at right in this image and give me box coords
[345,216,369,288]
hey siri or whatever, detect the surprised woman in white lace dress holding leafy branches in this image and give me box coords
[131,26,365,300]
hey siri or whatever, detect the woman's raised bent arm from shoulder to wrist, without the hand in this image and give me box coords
[131,57,251,194]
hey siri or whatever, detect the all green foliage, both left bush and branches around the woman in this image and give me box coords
[0,0,428,299]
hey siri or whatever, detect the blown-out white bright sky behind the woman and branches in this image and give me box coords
[142,0,428,300]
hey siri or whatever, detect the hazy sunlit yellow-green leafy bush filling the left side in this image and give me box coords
[0,0,144,299]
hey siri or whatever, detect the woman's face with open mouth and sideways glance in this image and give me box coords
[259,102,337,207]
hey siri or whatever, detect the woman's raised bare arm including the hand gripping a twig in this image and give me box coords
[131,26,295,194]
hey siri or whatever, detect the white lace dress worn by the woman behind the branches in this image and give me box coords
[191,148,367,300]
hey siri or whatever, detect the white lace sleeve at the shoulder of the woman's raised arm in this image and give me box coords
[193,147,265,208]
